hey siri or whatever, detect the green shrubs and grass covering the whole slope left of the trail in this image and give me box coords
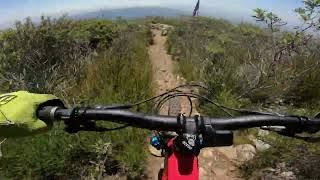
[0,16,153,179]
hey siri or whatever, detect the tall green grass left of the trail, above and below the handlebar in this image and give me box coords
[0,17,153,179]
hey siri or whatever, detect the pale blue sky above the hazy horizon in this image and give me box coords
[0,0,302,25]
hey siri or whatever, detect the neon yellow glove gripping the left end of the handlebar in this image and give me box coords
[0,91,63,138]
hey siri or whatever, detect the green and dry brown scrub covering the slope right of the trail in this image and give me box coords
[167,18,320,179]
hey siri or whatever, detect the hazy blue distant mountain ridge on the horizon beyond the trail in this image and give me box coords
[70,7,188,19]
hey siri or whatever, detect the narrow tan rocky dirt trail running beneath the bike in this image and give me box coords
[146,25,244,180]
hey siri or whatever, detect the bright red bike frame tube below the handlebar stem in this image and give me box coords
[161,139,199,180]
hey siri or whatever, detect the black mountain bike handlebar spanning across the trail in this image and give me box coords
[38,106,320,133]
